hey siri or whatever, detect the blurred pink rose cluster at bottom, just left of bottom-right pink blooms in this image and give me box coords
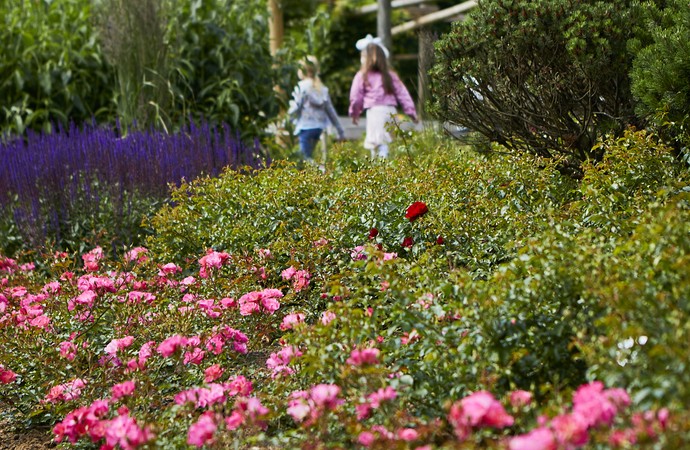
[448,391,514,441]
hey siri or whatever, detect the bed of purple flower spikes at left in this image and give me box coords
[0,119,270,253]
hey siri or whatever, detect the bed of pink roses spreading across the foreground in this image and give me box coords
[0,243,675,450]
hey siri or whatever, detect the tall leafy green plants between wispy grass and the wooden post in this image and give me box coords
[166,0,278,136]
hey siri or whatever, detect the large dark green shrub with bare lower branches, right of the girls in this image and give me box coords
[431,0,652,173]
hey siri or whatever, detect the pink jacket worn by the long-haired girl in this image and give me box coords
[349,71,417,120]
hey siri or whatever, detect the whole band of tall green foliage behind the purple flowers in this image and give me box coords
[0,0,281,137]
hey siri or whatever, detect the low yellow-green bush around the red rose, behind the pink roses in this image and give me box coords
[148,135,573,276]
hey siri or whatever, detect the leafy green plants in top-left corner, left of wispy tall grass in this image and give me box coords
[0,0,114,134]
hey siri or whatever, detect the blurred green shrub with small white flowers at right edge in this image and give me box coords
[588,196,690,405]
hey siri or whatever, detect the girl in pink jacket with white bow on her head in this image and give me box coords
[349,40,417,158]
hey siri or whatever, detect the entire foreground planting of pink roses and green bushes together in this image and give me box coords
[0,128,690,449]
